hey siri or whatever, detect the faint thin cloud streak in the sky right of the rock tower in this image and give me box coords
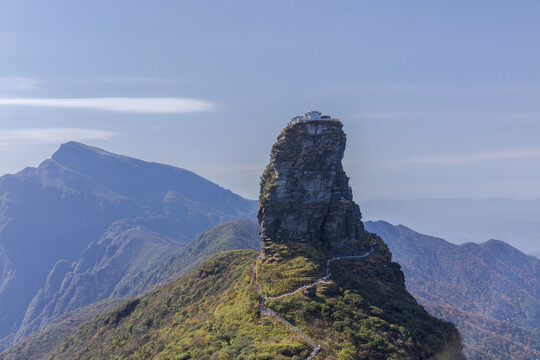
[396,148,540,164]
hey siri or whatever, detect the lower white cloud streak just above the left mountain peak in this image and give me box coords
[0,128,116,145]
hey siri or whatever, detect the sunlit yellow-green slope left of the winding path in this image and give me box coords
[16,250,320,360]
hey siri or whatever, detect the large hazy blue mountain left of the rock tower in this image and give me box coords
[0,142,256,348]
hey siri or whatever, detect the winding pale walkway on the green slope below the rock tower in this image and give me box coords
[253,249,373,360]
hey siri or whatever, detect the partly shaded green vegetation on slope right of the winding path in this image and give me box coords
[258,256,460,360]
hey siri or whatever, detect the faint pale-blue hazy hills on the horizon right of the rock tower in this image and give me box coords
[360,199,540,254]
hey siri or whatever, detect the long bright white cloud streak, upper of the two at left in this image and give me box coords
[0,97,215,114]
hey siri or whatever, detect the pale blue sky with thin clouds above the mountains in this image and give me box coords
[0,0,540,201]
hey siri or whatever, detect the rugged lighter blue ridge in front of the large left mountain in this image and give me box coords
[14,220,179,340]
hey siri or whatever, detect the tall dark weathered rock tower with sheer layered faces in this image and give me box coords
[257,120,369,257]
